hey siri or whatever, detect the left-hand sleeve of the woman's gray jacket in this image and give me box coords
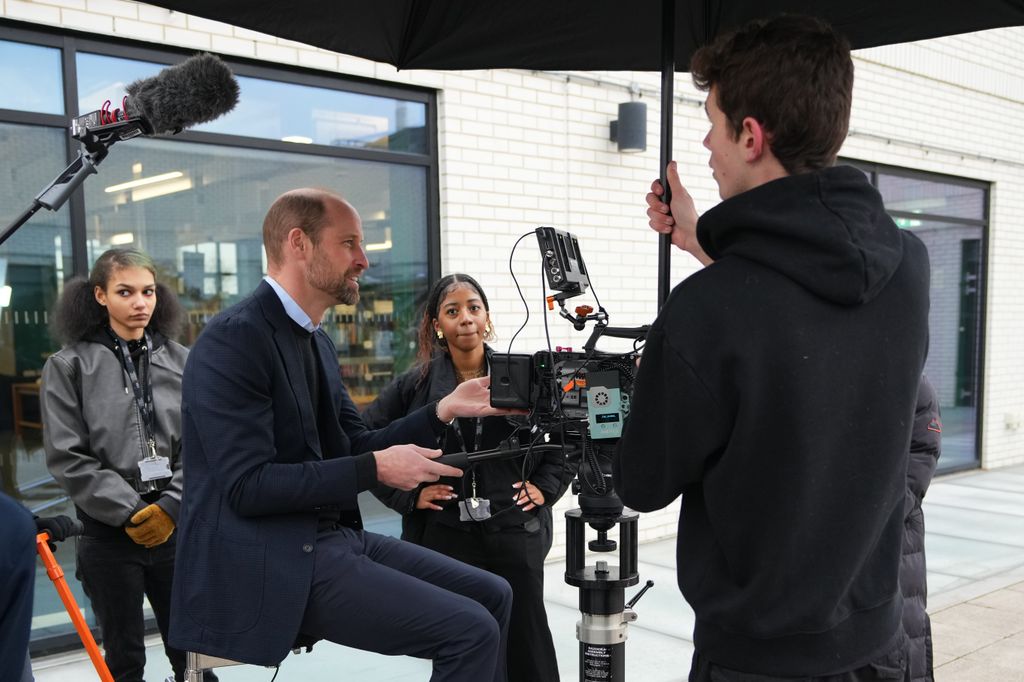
[40,354,141,527]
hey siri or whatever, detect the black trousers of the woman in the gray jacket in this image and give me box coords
[75,534,217,682]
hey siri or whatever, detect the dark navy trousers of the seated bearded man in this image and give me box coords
[300,527,512,682]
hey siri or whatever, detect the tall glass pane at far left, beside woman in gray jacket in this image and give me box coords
[0,123,81,640]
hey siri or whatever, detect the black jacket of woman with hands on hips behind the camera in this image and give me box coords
[362,347,565,543]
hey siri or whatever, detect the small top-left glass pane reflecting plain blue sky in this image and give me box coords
[0,40,65,114]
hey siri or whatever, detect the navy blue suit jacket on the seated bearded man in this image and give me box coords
[170,282,441,666]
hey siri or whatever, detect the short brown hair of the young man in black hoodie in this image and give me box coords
[690,14,853,174]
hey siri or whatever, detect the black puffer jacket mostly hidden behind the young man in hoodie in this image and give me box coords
[899,377,942,682]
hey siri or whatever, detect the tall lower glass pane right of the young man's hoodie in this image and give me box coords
[913,221,983,469]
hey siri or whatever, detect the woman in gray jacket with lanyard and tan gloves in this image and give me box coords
[41,249,216,682]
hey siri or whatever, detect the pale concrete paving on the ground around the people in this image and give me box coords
[33,466,1024,682]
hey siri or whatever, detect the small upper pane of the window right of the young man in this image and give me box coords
[879,173,985,220]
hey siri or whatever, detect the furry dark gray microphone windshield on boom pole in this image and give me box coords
[125,52,239,135]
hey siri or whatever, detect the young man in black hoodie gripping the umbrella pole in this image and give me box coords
[614,11,929,682]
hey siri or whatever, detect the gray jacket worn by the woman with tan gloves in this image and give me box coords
[40,333,188,527]
